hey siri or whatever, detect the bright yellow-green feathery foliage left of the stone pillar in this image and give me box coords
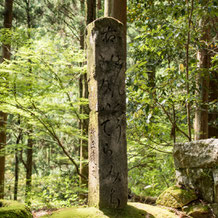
[0,29,87,156]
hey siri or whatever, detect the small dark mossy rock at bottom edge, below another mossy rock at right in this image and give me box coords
[184,203,212,218]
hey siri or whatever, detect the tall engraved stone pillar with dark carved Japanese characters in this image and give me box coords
[86,17,127,208]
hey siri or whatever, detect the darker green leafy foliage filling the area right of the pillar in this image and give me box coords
[126,0,216,196]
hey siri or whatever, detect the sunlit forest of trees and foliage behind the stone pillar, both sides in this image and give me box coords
[0,0,218,209]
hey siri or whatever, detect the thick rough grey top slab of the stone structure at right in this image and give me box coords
[173,139,218,169]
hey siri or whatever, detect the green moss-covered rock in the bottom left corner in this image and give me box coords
[0,199,33,218]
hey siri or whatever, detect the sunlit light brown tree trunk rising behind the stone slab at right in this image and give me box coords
[194,19,211,140]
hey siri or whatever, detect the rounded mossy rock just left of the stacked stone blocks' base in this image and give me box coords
[156,186,197,208]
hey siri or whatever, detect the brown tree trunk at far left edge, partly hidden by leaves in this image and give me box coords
[0,0,13,198]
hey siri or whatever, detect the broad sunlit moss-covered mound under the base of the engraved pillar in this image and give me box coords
[43,203,178,218]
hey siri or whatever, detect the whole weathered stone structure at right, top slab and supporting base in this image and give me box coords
[173,139,218,203]
